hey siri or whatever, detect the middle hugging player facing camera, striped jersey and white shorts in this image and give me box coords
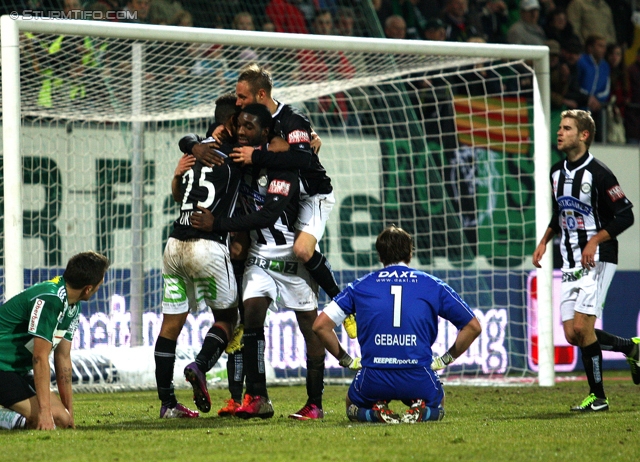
[200,104,325,420]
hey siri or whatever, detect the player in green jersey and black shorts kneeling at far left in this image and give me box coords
[0,252,109,430]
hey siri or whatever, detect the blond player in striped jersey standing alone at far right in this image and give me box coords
[533,109,640,412]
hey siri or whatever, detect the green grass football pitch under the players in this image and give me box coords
[0,371,640,462]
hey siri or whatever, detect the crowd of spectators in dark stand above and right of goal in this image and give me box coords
[5,0,640,144]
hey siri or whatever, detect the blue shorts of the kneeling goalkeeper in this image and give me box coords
[347,367,444,409]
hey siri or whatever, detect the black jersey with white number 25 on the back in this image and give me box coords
[171,159,242,242]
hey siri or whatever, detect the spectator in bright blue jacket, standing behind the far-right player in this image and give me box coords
[574,34,611,142]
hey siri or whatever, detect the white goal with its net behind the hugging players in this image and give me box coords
[0,17,549,386]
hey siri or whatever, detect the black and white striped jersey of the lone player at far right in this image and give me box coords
[549,152,633,269]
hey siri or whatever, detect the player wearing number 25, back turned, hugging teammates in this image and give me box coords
[154,125,242,419]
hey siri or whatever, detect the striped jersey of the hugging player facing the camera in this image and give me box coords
[213,162,300,258]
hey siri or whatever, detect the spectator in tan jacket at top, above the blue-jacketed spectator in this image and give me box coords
[567,0,616,46]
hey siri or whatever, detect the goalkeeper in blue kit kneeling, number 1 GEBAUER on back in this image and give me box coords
[313,226,482,423]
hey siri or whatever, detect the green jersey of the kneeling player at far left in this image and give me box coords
[0,276,80,374]
